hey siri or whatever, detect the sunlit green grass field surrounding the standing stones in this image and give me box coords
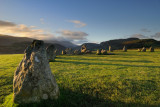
[0,50,160,107]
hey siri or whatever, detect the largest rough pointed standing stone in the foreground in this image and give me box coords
[13,40,59,104]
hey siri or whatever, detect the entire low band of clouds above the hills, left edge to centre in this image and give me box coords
[0,20,88,43]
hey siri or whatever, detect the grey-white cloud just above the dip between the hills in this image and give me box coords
[57,30,88,40]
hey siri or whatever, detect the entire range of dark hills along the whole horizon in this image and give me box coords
[0,35,160,54]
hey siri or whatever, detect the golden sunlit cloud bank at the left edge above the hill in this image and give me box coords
[0,20,54,39]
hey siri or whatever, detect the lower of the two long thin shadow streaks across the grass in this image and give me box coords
[56,60,160,68]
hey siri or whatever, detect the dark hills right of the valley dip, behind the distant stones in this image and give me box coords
[76,38,160,50]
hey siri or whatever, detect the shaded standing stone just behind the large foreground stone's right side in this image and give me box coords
[46,45,56,62]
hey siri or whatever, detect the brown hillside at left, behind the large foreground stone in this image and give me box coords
[0,35,66,54]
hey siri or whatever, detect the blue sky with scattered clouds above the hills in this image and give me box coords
[0,0,160,44]
